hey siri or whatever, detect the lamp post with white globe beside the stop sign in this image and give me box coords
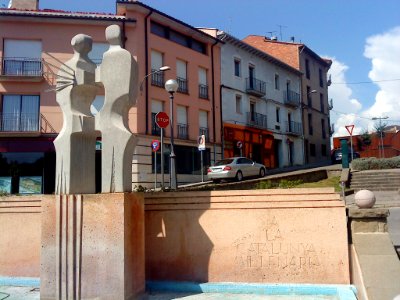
[165,79,178,190]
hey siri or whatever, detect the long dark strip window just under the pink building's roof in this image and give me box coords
[150,22,207,54]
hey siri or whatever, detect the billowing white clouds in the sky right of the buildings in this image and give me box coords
[329,27,400,137]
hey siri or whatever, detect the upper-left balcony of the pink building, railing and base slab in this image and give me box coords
[0,57,43,82]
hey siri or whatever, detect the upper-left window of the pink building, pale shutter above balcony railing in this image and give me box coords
[2,39,43,76]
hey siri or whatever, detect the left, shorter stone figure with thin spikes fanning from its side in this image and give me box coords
[54,34,97,194]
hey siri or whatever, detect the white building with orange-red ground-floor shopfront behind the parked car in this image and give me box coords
[211,30,304,168]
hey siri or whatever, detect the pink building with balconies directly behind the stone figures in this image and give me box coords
[0,0,221,193]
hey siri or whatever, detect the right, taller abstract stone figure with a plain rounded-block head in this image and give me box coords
[95,25,138,193]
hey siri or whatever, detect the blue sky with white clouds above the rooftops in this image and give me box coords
[0,0,400,136]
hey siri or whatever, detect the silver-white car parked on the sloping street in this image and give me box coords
[207,157,266,182]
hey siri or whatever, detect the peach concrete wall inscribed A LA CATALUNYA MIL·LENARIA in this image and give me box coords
[145,188,350,284]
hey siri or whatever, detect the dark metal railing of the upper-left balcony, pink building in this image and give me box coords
[1,57,43,77]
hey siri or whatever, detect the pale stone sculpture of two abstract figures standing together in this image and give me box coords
[54,25,138,194]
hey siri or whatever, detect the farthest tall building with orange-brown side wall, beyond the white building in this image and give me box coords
[244,35,333,164]
